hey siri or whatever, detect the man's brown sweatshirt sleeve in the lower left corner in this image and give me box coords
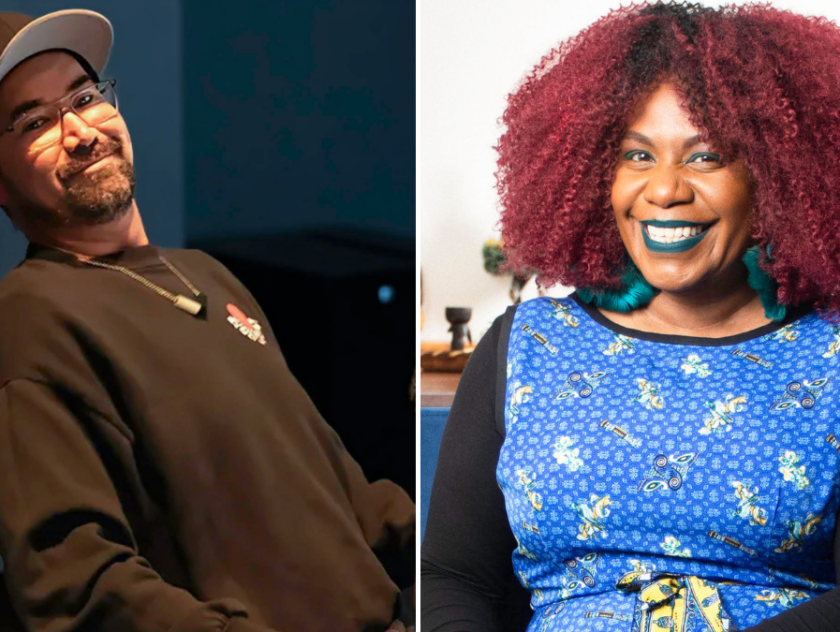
[0,380,278,632]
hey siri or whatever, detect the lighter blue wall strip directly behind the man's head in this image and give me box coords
[0,0,184,276]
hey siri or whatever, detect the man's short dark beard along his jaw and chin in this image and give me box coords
[6,139,136,228]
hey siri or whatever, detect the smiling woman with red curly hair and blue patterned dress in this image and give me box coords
[422,3,840,632]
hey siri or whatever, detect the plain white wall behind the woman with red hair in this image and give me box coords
[417,0,840,341]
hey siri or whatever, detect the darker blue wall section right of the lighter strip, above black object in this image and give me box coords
[183,0,415,241]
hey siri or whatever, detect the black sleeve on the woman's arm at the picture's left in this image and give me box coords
[420,309,531,632]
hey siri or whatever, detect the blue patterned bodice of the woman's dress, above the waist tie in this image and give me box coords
[497,311,840,575]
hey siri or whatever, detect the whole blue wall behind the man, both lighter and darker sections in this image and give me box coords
[0,0,415,276]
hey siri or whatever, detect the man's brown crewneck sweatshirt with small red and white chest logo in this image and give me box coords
[0,246,414,632]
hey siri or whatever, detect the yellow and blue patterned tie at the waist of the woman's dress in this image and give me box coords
[615,571,736,632]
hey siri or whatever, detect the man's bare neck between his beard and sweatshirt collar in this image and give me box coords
[30,201,149,259]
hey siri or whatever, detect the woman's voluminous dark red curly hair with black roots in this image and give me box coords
[497,2,840,310]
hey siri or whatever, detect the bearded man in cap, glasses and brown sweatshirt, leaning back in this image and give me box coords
[0,11,414,632]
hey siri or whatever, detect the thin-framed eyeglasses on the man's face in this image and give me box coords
[0,79,118,151]
